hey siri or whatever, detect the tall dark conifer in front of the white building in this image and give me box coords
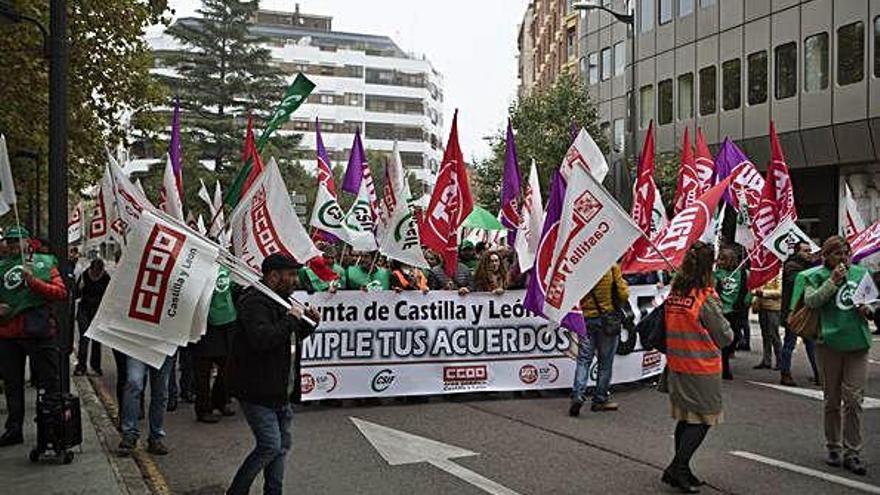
[159,0,299,176]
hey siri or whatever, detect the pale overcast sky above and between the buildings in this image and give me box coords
[158,0,528,160]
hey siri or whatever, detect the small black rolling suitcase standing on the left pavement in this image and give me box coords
[29,393,82,464]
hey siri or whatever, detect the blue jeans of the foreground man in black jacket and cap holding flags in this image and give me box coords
[226,401,293,495]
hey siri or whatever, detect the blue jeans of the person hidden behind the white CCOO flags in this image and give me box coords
[122,356,171,440]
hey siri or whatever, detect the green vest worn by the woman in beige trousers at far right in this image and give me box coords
[806,265,871,352]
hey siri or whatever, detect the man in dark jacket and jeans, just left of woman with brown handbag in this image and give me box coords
[779,242,819,387]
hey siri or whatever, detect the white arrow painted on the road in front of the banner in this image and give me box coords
[348,417,519,495]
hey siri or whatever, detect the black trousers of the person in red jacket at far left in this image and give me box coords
[0,337,61,431]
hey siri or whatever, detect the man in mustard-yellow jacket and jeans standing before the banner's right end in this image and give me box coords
[568,265,629,416]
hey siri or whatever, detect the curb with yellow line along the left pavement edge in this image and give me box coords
[73,377,172,495]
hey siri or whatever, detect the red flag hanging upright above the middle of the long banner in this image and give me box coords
[421,110,474,277]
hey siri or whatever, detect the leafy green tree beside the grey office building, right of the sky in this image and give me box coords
[473,73,608,210]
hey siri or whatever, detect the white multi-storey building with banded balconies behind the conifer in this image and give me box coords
[148,5,443,181]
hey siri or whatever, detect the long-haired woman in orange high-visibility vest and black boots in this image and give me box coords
[662,242,733,493]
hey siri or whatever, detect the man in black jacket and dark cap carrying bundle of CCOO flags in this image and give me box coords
[227,254,319,495]
